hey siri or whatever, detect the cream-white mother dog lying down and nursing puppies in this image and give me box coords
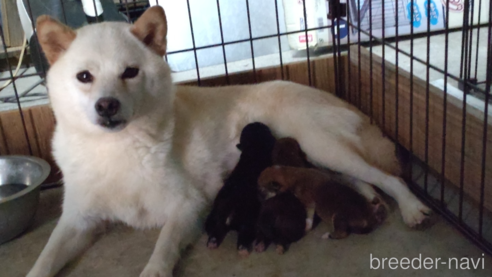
[28,4,429,277]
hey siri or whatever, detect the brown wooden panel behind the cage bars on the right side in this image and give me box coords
[349,46,492,211]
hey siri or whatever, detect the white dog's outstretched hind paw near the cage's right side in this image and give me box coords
[400,199,432,229]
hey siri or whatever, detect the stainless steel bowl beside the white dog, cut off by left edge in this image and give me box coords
[0,156,50,244]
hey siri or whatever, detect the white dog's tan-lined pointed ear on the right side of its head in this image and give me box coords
[131,6,167,56]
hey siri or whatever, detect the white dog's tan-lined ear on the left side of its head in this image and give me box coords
[36,15,76,64]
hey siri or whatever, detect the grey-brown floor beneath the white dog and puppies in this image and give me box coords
[0,185,492,277]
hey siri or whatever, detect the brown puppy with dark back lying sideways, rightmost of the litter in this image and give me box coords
[258,166,386,239]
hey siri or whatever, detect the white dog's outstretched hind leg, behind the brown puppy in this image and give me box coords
[301,138,431,227]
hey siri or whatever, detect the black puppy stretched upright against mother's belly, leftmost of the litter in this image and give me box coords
[205,122,275,256]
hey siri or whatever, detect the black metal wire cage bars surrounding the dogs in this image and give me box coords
[0,0,492,253]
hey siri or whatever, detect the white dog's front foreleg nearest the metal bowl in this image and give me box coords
[27,214,96,277]
